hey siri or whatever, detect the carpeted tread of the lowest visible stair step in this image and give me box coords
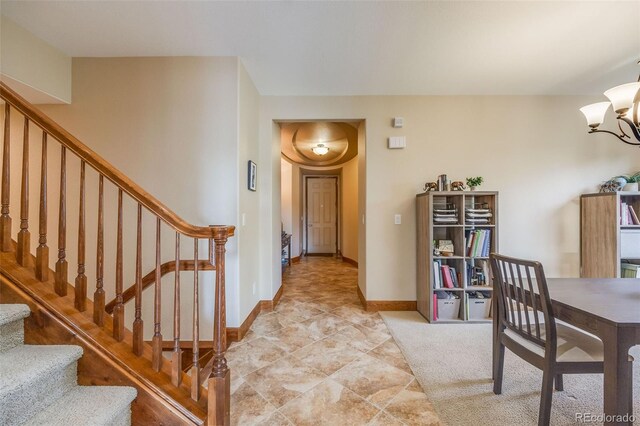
[25,386,137,426]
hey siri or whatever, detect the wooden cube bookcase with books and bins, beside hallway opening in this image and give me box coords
[416,191,498,322]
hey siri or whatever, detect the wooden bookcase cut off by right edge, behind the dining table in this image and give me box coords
[580,192,640,278]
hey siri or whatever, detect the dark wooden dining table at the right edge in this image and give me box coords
[494,278,640,425]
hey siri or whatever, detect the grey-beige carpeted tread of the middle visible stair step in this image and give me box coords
[0,345,82,394]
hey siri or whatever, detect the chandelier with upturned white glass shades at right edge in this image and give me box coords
[580,61,640,146]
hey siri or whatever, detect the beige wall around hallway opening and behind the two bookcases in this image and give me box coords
[261,96,639,300]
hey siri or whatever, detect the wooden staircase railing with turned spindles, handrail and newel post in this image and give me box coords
[0,82,235,425]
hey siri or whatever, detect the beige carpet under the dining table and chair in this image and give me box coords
[380,312,640,426]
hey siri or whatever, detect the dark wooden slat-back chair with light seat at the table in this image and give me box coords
[491,253,604,426]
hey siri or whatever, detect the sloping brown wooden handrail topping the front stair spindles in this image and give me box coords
[0,81,235,239]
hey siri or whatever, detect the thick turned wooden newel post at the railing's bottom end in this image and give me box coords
[207,227,231,426]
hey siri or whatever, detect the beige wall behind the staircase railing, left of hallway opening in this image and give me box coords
[32,57,249,330]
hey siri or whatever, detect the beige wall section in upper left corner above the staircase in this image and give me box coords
[0,16,71,103]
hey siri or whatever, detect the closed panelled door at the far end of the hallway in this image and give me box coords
[306,177,338,254]
